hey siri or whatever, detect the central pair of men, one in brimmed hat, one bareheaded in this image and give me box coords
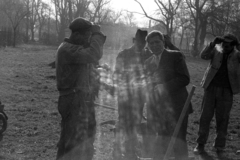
[111,30,192,160]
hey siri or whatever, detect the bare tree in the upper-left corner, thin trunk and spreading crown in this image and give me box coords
[0,0,29,47]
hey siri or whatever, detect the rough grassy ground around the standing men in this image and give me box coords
[0,45,240,160]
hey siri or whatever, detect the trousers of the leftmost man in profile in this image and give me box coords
[57,93,96,160]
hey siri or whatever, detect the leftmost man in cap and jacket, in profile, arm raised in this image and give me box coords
[56,17,106,160]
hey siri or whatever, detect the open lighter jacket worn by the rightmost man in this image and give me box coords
[201,45,240,94]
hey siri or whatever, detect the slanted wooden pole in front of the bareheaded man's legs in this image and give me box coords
[163,86,196,160]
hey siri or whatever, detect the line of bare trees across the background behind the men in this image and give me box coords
[0,0,240,56]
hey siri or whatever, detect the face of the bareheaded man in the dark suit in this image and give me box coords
[148,35,164,53]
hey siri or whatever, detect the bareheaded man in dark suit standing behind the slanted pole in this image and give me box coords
[145,31,192,160]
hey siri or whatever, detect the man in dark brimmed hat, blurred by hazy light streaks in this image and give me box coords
[113,29,148,160]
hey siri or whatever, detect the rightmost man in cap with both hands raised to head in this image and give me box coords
[194,33,240,154]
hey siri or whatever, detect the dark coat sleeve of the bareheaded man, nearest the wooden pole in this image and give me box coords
[163,52,190,92]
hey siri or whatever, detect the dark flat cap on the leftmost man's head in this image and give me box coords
[69,17,93,32]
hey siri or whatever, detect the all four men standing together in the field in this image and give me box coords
[56,18,240,160]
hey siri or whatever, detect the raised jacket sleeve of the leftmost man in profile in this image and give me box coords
[66,33,106,64]
